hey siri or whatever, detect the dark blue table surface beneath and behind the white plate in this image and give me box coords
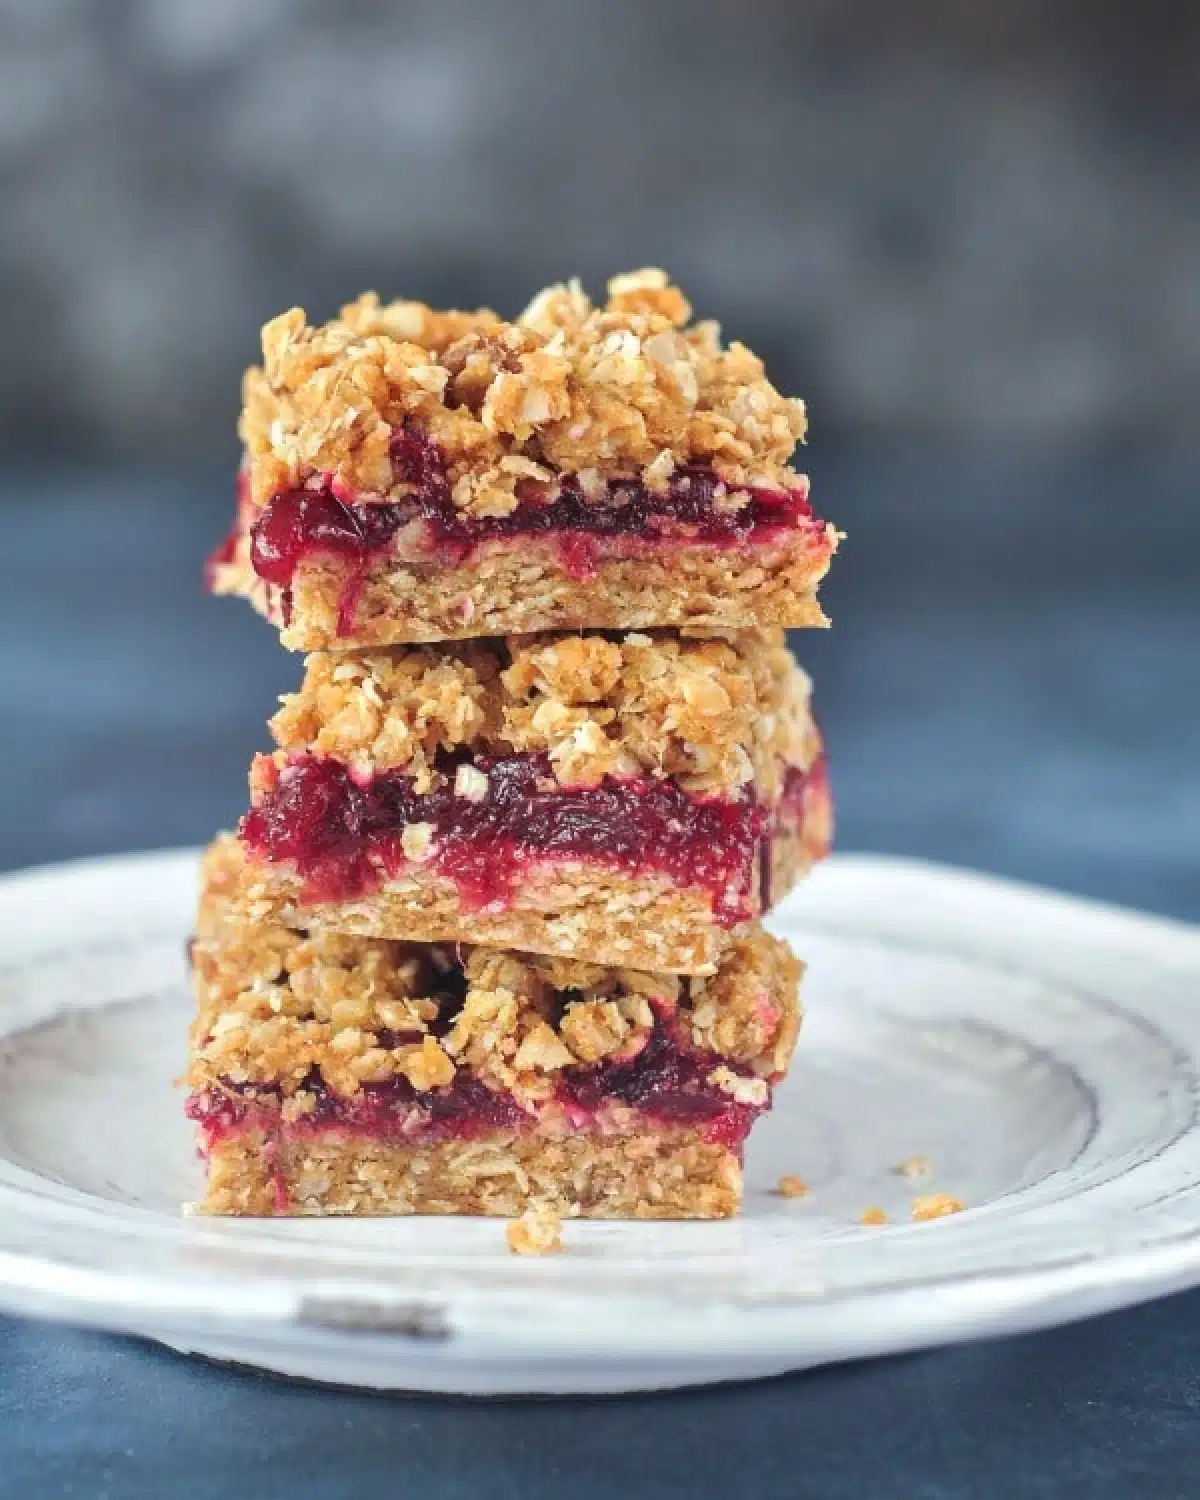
[0,453,1200,1500]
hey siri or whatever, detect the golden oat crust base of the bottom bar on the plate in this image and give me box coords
[198,1130,743,1220]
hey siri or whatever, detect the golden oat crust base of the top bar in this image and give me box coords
[212,527,839,651]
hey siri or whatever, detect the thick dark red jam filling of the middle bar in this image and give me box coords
[242,755,768,926]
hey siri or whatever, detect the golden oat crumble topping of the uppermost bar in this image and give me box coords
[240,269,806,518]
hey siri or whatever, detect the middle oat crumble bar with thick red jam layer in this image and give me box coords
[234,632,831,974]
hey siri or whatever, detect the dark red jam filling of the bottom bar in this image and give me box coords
[186,1013,770,1151]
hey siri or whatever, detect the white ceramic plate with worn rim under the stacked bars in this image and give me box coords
[0,854,1200,1394]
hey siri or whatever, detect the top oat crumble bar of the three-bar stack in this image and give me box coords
[209,270,837,651]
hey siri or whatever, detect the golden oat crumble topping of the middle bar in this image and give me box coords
[265,632,821,800]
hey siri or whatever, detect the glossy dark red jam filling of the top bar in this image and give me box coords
[237,428,819,612]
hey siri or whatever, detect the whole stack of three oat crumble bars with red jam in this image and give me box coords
[189,270,837,1218]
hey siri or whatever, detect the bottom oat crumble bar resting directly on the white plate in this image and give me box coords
[188,842,803,1218]
